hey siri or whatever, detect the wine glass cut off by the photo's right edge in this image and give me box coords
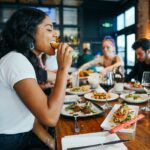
[141,71,150,111]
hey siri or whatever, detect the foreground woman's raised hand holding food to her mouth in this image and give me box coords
[57,43,73,70]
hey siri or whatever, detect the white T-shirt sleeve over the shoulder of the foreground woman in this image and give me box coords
[0,52,36,86]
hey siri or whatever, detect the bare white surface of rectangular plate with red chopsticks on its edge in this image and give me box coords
[101,104,139,133]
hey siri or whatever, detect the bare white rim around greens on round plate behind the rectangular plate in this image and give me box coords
[120,94,150,103]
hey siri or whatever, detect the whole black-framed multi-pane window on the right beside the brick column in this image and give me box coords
[116,6,136,72]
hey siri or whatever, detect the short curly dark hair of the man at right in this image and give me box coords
[132,38,150,51]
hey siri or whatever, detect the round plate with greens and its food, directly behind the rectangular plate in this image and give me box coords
[120,94,150,103]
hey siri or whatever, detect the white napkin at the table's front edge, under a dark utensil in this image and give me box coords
[62,132,127,150]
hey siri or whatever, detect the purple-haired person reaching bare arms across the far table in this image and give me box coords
[79,36,123,75]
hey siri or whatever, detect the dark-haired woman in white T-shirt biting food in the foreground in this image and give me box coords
[0,8,72,150]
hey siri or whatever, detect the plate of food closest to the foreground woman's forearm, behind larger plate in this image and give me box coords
[66,85,91,95]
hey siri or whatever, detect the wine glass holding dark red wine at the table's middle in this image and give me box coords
[100,72,114,110]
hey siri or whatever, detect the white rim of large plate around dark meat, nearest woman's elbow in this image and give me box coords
[61,103,103,117]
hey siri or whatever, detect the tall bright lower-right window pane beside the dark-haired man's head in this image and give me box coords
[127,34,135,66]
